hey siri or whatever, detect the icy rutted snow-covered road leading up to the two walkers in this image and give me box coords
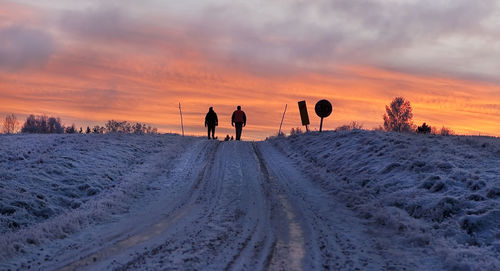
[0,140,443,270]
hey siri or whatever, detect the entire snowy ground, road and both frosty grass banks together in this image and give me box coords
[0,130,500,270]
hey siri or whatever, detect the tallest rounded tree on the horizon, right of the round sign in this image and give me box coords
[384,97,414,132]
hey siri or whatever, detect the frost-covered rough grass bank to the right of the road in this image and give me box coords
[270,130,500,270]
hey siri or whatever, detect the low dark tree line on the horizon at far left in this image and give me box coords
[2,114,158,135]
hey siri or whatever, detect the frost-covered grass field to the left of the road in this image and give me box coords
[0,134,193,259]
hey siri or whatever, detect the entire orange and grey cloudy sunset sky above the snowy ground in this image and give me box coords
[0,0,500,140]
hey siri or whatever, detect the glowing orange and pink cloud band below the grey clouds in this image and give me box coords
[0,1,500,139]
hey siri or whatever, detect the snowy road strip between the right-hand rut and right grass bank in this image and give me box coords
[258,142,394,270]
